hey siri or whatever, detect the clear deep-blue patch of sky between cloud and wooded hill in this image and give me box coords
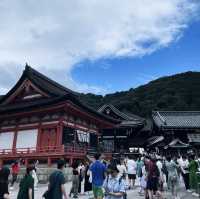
[72,20,200,92]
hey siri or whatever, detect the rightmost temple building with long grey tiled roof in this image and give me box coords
[150,111,200,152]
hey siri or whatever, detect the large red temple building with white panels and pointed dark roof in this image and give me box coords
[0,65,119,165]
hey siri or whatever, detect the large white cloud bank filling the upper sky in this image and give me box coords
[0,0,199,92]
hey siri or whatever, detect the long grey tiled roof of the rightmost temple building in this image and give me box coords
[152,111,200,128]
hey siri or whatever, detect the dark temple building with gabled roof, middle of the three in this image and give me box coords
[98,104,148,153]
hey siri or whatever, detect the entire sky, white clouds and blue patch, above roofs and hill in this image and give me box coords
[0,0,200,94]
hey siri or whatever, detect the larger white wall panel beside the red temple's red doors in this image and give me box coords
[16,129,38,149]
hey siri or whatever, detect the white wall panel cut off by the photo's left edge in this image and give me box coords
[0,132,14,149]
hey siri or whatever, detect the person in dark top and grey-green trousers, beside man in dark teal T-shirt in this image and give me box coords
[69,162,79,198]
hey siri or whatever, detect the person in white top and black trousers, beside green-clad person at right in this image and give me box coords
[179,156,190,192]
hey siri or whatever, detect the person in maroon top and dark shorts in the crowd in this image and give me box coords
[147,157,162,199]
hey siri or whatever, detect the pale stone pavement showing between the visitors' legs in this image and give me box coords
[7,183,198,199]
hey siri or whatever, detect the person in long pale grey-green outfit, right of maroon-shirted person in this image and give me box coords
[165,156,179,198]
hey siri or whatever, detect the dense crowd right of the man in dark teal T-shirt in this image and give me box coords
[70,154,200,199]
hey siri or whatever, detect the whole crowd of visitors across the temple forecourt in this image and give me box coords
[0,154,199,199]
